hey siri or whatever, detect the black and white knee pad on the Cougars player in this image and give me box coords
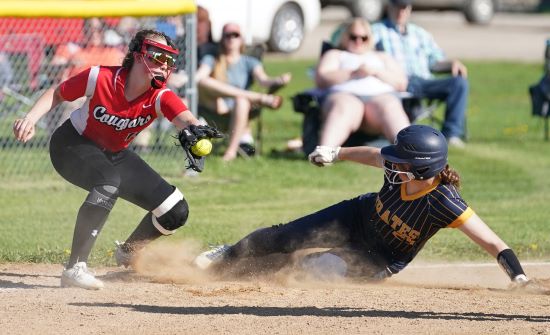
[152,188,189,235]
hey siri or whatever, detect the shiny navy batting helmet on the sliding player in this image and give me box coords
[382,125,447,179]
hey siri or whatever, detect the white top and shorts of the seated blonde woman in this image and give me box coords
[330,51,395,96]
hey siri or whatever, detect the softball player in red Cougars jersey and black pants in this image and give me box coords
[13,30,206,289]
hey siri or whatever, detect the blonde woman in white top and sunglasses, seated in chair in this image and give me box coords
[315,18,410,147]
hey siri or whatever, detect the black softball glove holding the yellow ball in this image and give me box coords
[178,125,223,172]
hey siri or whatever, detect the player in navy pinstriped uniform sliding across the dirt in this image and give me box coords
[195,125,540,292]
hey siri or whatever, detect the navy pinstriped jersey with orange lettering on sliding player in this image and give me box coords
[371,171,474,263]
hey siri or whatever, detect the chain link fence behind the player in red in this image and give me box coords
[0,14,196,180]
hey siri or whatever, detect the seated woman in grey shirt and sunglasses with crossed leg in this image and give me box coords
[197,23,291,161]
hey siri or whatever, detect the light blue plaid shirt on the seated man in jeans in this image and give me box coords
[372,19,445,79]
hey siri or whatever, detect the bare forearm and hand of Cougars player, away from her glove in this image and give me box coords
[13,87,64,142]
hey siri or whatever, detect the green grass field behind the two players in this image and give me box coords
[0,61,550,264]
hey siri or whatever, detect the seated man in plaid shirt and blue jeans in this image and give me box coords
[372,0,468,147]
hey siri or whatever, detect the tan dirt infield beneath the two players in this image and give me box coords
[0,244,550,335]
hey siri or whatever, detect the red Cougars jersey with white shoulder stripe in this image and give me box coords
[59,66,188,152]
